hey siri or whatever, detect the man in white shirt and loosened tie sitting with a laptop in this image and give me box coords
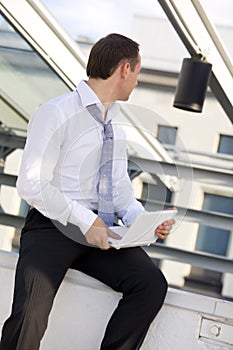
[0,34,174,350]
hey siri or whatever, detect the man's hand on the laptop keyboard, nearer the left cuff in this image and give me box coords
[85,217,121,250]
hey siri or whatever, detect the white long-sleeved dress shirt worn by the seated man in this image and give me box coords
[16,81,144,234]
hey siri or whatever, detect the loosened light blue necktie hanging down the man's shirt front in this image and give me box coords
[87,104,114,226]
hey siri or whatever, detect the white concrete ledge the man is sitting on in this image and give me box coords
[0,251,233,350]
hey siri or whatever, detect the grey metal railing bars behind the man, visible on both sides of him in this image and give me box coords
[0,153,233,273]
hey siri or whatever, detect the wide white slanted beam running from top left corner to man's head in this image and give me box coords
[0,0,85,90]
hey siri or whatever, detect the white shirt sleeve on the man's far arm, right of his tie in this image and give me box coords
[113,129,145,226]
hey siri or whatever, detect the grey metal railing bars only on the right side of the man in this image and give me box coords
[129,156,233,274]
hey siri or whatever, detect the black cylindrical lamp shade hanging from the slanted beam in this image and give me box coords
[173,58,212,113]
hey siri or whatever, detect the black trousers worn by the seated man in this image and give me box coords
[0,209,167,350]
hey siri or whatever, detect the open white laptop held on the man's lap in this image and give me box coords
[109,209,177,249]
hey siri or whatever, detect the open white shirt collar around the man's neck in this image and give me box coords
[76,80,120,122]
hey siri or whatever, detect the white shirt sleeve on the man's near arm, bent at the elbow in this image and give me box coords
[16,104,97,234]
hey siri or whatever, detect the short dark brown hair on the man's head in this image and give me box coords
[86,34,139,79]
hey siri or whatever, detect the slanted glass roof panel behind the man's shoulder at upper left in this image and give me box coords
[0,16,69,133]
